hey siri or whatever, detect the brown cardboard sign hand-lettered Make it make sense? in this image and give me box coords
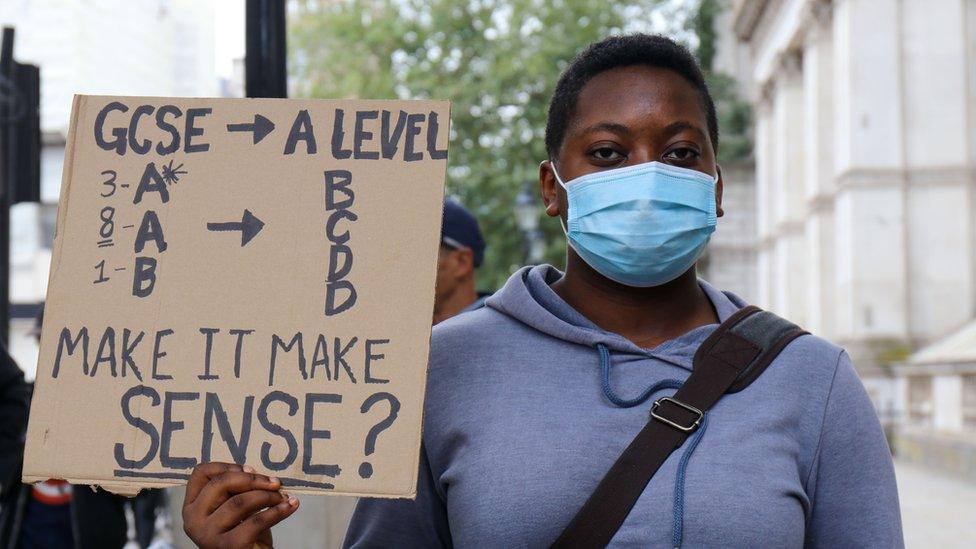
[24,96,450,497]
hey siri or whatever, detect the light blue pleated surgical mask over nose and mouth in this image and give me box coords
[552,162,718,288]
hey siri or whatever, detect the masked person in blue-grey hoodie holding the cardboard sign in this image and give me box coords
[185,35,903,547]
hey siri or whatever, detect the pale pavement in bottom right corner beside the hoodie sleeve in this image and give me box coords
[895,460,976,549]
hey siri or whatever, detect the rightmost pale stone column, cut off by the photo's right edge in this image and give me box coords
[899,1,976,343]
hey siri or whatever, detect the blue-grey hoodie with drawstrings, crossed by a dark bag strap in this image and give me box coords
[345,266,903,548]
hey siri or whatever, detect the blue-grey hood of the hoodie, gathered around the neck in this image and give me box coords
[485,265,746,370]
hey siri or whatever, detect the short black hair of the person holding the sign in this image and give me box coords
[546,33,718,159]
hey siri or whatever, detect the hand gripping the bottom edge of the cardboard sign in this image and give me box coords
[183,462,298,549]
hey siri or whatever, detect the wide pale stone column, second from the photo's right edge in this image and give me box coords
[832,0,908,360]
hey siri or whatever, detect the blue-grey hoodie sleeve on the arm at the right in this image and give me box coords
[806,353,905,548]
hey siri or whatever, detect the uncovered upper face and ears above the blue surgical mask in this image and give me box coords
[539,65,723,223]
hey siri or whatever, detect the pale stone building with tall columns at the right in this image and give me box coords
[716,0,976,470]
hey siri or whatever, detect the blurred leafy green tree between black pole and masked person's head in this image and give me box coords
[288,0,687,288]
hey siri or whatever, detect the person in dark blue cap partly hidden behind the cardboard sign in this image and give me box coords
[434,199,490,324]
